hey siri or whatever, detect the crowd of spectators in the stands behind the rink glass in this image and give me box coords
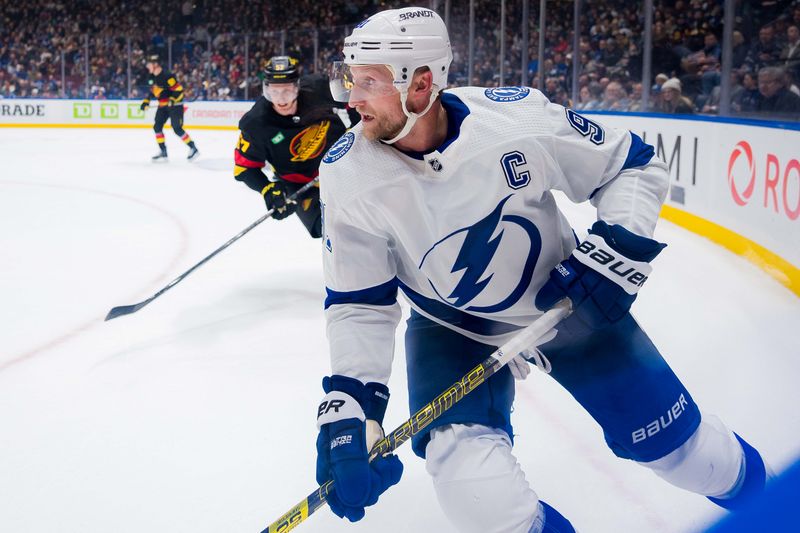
[0,0,800,119]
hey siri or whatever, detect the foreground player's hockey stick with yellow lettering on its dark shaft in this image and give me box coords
[261,298,572,533]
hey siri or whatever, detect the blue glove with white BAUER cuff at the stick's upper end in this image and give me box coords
[535,220,666,330]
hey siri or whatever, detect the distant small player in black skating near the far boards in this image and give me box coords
[140,55,200,162]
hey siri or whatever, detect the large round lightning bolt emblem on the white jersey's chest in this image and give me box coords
[419,194,542,313]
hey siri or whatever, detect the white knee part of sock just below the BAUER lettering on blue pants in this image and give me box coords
[639,414,744,496]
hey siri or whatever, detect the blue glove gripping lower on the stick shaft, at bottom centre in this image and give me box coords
[317,375,403,522]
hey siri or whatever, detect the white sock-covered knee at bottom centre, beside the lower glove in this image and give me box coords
[426,424,539,533]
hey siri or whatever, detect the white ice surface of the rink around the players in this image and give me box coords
[0,127,800,533]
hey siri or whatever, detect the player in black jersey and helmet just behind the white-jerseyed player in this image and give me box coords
[234,56,359,238]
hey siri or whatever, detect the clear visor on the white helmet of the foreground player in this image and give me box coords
[329,61,398,102]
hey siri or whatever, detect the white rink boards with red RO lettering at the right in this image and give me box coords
[592,114,800,267]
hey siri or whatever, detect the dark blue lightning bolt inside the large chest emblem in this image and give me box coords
[449,195,511,307]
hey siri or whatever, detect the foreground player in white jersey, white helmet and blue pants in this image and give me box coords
[317,8,765,533]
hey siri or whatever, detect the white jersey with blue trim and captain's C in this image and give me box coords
[320,87,668,383]
